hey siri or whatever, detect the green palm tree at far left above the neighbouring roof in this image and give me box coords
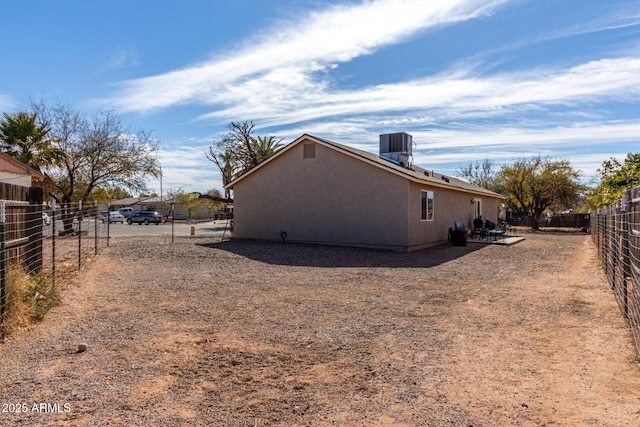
[0,111,64,172]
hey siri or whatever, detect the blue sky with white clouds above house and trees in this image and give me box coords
[0,0,640,195]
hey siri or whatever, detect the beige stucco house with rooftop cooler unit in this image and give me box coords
[225,133,503,251]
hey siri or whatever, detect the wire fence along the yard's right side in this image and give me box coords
[591,187,640,355]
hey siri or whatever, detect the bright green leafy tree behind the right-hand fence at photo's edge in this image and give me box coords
[587,153,640,207]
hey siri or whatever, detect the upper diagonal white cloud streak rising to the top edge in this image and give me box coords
[100,0,509,111]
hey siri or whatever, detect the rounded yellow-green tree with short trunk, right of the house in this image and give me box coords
[496,156,585,230]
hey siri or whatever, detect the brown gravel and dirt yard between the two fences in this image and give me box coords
[0,233,640,426]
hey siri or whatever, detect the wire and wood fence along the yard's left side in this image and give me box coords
[0,200,109,338]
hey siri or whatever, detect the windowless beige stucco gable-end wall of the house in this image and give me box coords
[233,139,409,249]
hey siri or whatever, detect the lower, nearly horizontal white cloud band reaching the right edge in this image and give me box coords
[202,57,640,126]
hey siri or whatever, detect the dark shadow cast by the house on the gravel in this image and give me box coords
[201,240,485,268]
